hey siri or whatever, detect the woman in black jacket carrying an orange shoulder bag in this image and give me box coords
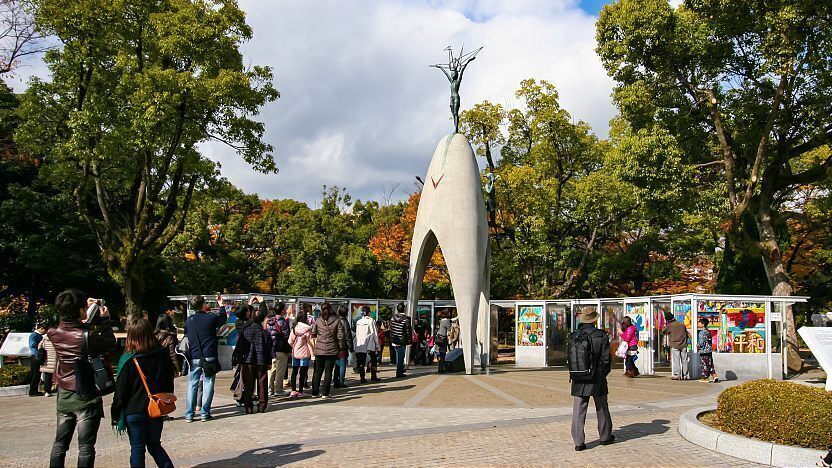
[110,319,174,468]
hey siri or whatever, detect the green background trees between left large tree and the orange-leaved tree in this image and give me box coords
[165,184,394,297]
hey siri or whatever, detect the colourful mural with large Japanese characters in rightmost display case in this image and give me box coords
[697,301,766,353]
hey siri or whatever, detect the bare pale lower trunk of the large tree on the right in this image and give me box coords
[755,204,803,372]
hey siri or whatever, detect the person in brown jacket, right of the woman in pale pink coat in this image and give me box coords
[312,303,347,399]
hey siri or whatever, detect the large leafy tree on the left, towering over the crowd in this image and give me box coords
[17,0,278,315]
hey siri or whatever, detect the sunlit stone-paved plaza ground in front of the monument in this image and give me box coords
[0,368,746,467]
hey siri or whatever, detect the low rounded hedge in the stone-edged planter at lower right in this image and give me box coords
[716,379,832,450]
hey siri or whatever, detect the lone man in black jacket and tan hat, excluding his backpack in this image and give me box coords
[572,307,615,451]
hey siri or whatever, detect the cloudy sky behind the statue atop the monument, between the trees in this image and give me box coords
[8,0,664,205]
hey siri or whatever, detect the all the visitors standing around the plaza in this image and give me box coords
[22,290,752,467]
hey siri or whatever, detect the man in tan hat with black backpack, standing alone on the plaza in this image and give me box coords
[567,307,615,452]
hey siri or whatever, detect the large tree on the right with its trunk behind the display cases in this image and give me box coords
[597,0,832,369]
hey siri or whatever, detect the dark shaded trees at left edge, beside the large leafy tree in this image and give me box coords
[0,79,117,310]
